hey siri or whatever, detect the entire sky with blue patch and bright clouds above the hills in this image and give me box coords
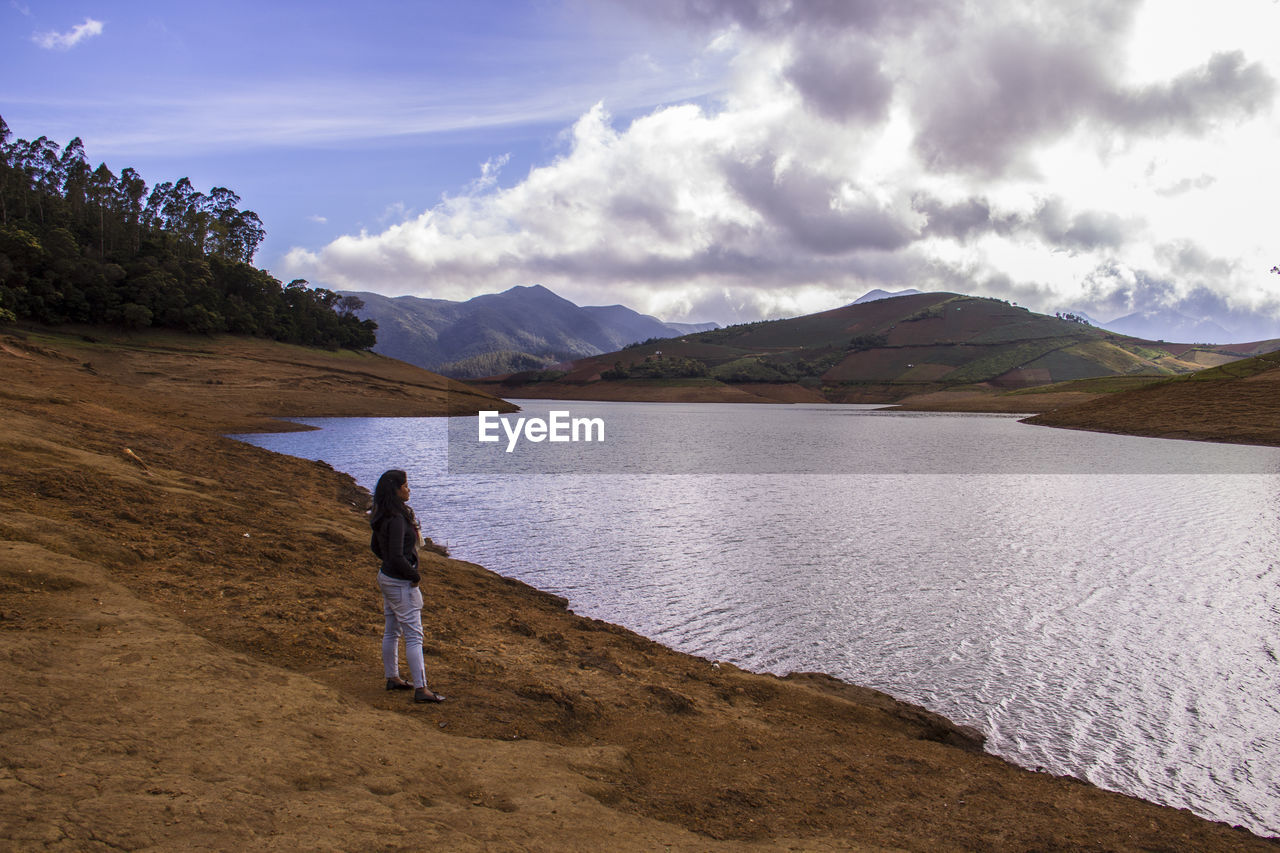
[0,0,1280,341]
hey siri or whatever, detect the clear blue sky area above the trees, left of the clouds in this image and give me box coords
[0,0,698,256]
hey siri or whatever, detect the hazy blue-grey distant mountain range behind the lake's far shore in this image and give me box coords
[340,284,719,379]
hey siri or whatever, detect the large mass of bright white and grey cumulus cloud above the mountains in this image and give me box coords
[285,0,1275,321]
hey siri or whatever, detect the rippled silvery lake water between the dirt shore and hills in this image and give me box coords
[232,401,1280,835]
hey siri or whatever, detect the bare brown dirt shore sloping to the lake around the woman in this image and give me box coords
[0,326,1277,850]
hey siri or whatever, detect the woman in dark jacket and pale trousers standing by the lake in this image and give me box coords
[369,470,444,702]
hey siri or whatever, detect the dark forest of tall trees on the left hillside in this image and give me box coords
[0,118,378,350]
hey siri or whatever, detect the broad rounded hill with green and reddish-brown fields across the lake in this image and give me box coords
[481,293,1280,402]
